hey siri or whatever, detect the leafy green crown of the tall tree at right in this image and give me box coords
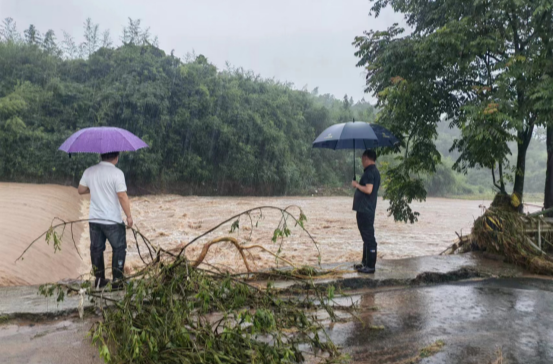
[354,0,552,222]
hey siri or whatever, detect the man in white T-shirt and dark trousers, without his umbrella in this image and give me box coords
[78,152,133,288]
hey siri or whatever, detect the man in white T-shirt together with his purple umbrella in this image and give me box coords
[59,126,148,288]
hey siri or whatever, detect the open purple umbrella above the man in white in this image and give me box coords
[59,126,148,154]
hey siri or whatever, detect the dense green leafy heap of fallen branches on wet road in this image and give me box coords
[83,259,348,363]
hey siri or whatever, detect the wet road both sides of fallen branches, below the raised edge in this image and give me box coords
[4,278,553,364]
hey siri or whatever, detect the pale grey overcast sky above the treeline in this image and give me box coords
[0,0,404,101]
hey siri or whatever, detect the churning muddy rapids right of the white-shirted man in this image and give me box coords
[97,195,489,270]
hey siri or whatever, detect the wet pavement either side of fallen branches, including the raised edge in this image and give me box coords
[0,253,553,364]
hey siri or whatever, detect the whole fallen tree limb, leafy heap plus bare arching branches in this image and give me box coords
[29,207,355,364]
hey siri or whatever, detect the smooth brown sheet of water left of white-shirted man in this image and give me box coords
[0,183,87,286]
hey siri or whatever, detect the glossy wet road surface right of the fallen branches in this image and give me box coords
[328,278,553,364]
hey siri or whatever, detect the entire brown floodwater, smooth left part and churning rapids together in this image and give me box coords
[0,183,537,286]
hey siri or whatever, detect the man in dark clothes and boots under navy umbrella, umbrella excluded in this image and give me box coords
[351,149,380,274]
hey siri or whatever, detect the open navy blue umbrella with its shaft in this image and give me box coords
[313,120,398,179]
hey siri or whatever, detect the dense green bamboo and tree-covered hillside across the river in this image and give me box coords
[0,19,375,195]
